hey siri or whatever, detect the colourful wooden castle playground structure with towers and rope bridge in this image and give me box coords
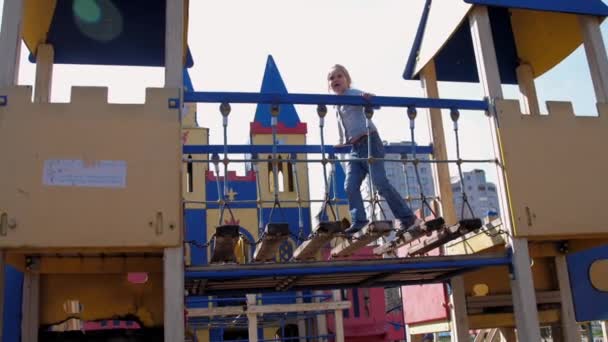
[0,0,608,341]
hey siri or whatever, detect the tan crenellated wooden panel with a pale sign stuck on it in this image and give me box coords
[0,87,182,248]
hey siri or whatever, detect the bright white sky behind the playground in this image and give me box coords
[0,0,607,211]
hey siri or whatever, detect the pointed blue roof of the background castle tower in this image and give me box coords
[253,55,301,129]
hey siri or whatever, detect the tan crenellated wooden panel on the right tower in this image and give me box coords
[496,101,608,239]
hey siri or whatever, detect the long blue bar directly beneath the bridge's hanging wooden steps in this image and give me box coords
[185,256,511,280]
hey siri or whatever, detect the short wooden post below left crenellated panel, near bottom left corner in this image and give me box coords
[21,270,40,342]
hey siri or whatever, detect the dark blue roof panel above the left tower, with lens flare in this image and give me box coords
[30,0,193,67]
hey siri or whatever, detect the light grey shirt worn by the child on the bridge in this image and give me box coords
[336,88,376,144]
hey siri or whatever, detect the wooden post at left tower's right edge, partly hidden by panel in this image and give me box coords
[163,0,185,341]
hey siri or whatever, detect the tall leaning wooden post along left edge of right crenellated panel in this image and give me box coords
[469,6,541,341]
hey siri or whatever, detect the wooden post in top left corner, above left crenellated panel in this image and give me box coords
[0,0,23,88]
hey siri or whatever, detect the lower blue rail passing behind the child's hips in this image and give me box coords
[183,145,433,154]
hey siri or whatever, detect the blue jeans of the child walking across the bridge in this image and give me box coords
[344,132,416,227]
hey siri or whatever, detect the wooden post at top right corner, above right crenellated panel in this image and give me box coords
[578,15,608,103]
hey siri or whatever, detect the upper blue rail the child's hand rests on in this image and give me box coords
[184,91,488,111]
